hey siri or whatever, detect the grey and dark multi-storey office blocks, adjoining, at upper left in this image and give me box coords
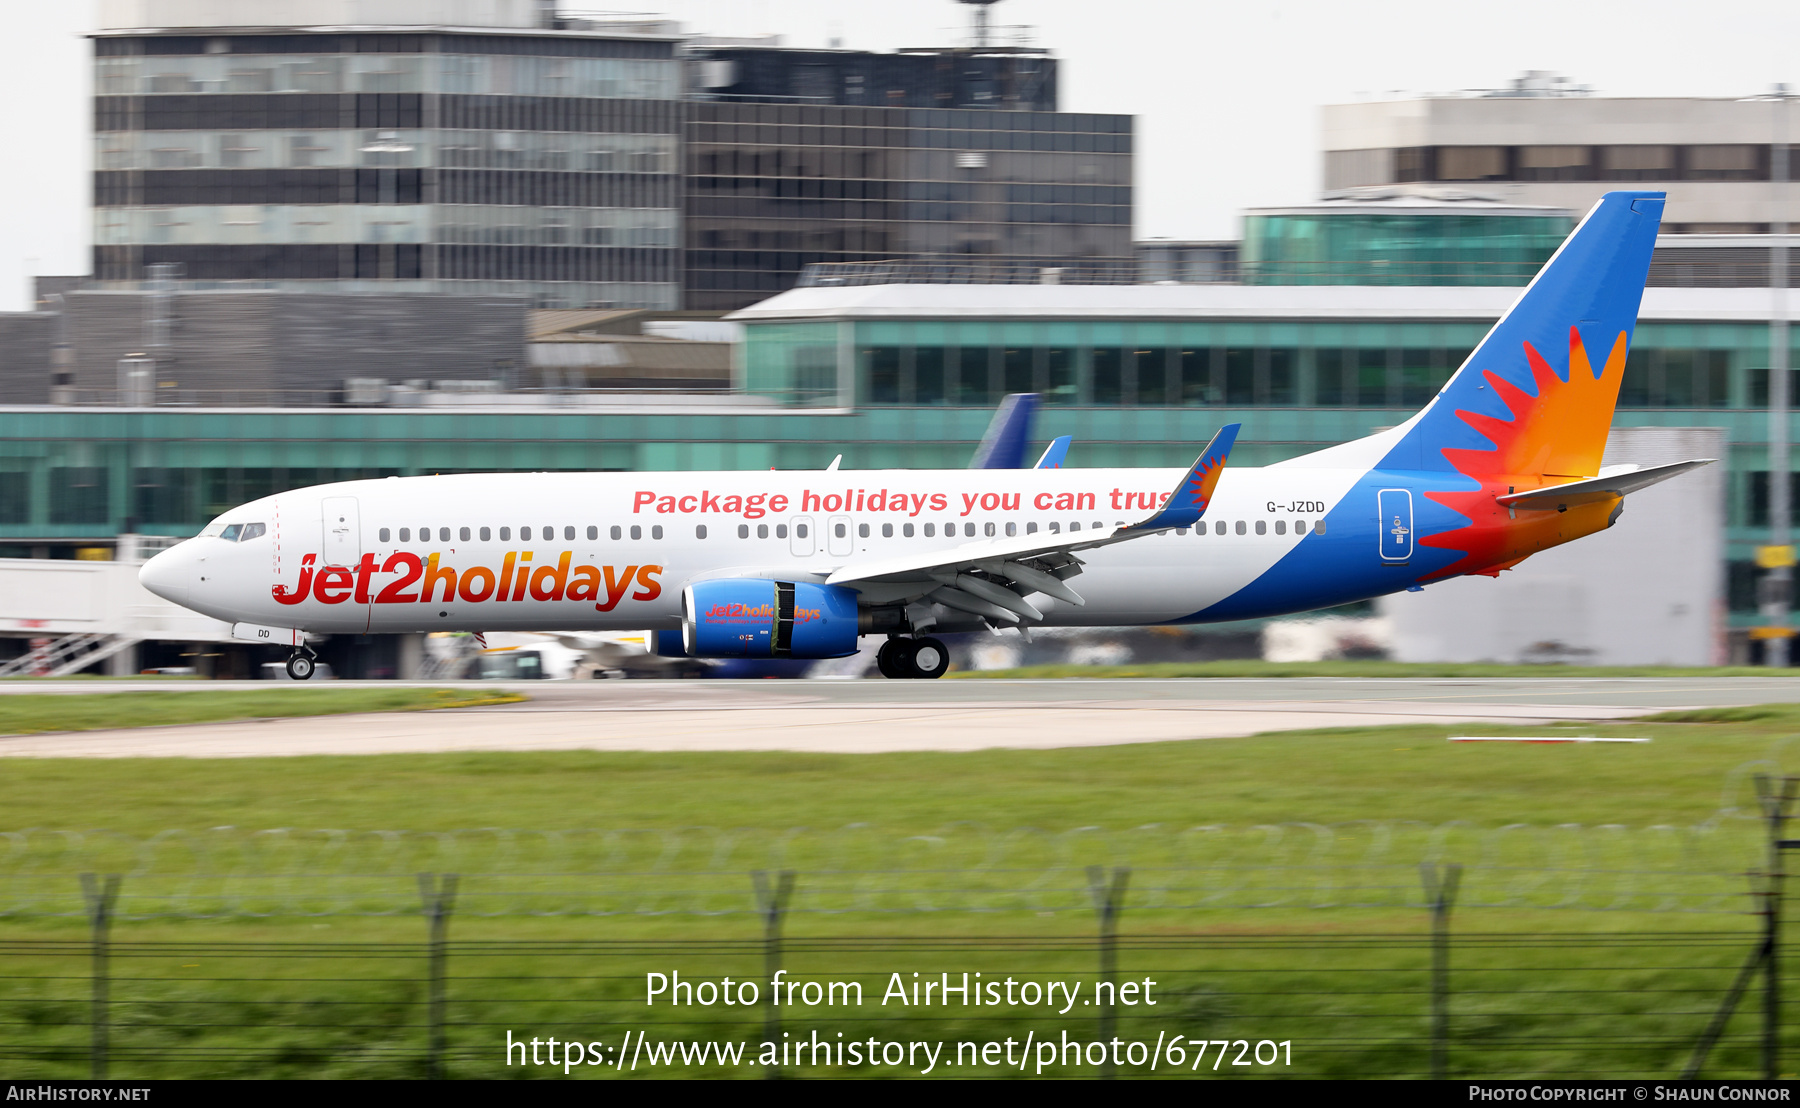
[94,0,1132,311]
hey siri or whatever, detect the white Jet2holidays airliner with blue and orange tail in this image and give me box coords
[140,192,1705,678]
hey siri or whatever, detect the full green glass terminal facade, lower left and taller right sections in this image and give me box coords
[0,302,1800,622]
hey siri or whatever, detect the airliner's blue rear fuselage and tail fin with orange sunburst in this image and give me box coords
[1197,192,1663,619]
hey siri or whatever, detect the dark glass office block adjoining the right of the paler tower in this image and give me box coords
[684,40,1132,309]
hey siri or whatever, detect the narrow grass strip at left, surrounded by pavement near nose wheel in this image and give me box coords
[0,689,524,736]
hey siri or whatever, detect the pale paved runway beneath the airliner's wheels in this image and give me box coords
[0,676,1800,757]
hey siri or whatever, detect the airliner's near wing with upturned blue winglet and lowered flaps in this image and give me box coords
[826,423,1238,624]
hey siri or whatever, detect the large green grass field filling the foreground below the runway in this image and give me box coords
[0,691,1800,1077]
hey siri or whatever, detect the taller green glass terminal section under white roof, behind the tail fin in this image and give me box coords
[727,320,1800,619]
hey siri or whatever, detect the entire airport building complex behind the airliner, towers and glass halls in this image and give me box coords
[0,21,1800,675]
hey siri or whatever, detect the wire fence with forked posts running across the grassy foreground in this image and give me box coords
[10,805,1800,1077]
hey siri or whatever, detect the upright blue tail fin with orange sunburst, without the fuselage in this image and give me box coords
[1370,192,1663,480]
